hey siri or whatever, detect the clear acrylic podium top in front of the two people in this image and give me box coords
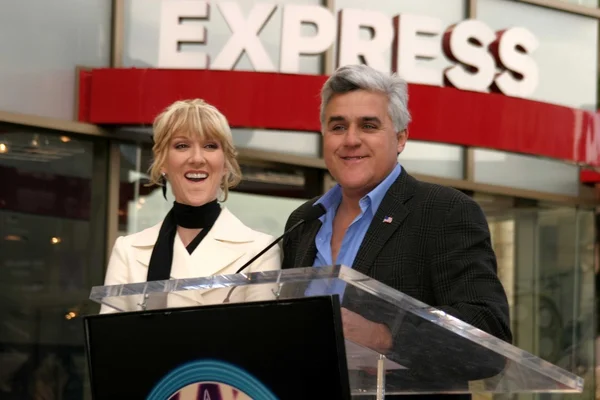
[90,266,584,398]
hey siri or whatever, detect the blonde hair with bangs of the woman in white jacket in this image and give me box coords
[149,99,242,201]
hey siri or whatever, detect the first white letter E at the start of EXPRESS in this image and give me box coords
[158,0,209,69]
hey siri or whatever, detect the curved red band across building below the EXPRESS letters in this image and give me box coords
[79,69,600,172]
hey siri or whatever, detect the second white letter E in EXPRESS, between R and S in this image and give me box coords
[392,14,443,86]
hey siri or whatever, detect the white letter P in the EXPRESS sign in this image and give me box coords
[279,4,335,74]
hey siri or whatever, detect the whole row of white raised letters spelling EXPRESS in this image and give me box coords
[158,0,538,97]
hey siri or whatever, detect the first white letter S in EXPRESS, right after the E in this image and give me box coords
[444,20,496,92]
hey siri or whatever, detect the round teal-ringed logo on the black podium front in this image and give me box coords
[147,360,278,400]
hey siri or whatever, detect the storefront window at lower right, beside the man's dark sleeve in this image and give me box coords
[486,195,596,399]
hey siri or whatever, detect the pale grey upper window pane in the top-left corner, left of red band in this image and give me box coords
[0,0,113,120]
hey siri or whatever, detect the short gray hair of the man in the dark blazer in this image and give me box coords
[321,64,410,132]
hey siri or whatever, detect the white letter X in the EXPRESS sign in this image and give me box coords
[211,2,277,72]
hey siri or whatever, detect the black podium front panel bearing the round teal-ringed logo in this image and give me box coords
[85,296,350,400]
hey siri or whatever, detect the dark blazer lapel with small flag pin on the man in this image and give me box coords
[353,168,417,275]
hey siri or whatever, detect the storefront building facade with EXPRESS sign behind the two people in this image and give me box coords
[0,0,600,400]
